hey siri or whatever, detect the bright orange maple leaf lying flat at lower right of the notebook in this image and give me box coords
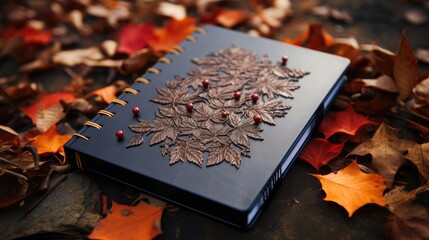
[310,161,387,217]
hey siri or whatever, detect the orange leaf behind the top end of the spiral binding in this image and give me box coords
[147,17,197,52]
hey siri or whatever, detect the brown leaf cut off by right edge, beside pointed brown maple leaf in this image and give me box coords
[404,143,429,182]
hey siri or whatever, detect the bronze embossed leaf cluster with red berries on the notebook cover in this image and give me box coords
[127,46,308,168]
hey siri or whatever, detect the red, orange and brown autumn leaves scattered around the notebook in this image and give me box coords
[0,0,429,239]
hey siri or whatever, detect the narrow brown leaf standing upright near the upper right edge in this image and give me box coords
[393,33,419,100]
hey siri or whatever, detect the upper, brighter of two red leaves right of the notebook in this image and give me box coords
[319,106,378,138]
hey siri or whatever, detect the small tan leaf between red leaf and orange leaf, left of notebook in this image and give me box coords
[34,103,65,132]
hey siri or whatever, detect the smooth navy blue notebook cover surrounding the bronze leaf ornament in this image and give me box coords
[65,26,349,227]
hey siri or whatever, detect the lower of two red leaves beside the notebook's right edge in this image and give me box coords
[299,138,344,171]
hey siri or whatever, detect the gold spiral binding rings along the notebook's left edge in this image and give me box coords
[73,27,206,170]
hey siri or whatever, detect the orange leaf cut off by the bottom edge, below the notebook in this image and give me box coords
[88,201,162,240]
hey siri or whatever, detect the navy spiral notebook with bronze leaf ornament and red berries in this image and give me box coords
[65,26,349,228]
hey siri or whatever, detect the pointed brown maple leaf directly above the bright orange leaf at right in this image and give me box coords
[348,123,415,188]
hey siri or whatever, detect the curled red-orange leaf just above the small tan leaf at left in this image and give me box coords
[21,92,75,122]
